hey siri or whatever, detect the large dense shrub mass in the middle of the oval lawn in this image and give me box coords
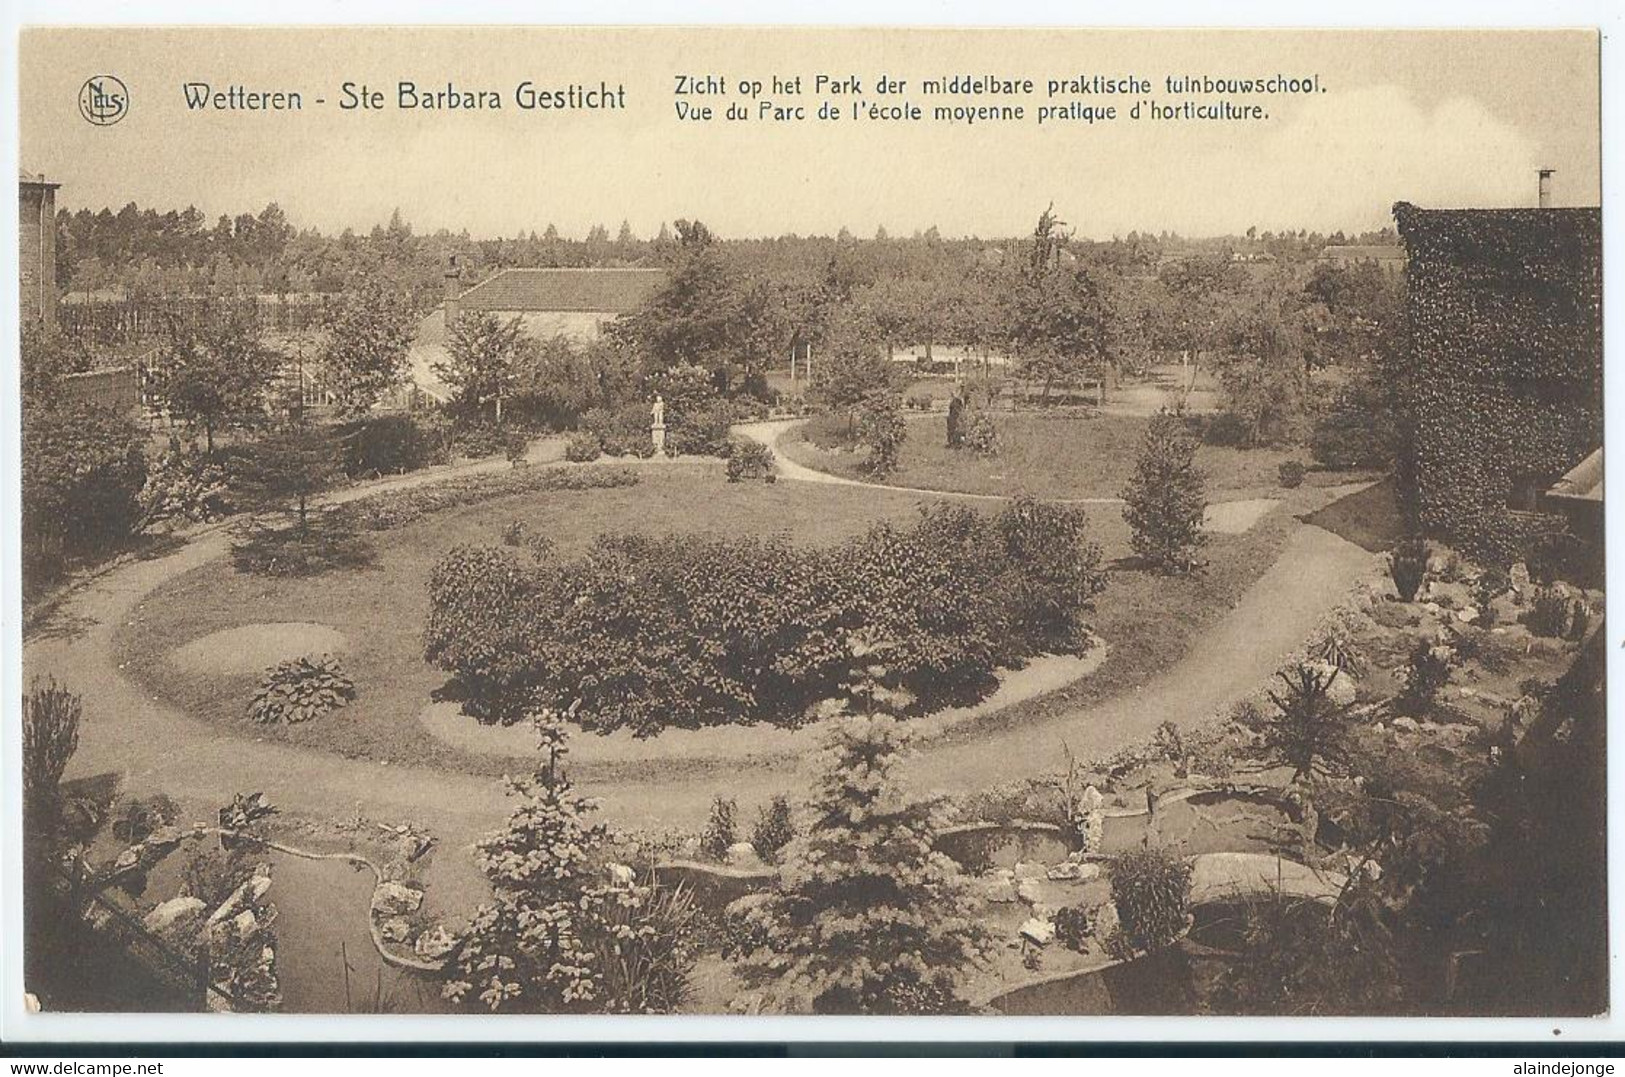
[426,500,1105,736]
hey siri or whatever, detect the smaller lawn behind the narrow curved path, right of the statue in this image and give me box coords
[780,413,1342,500]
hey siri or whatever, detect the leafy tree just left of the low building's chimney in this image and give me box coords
[322,281,416,414]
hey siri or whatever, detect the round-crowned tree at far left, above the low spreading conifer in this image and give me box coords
[153,307,280,453]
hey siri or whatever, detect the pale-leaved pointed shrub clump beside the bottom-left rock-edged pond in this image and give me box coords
[444,713,694,1014]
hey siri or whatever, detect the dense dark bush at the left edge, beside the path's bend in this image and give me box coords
[21,403,146,578]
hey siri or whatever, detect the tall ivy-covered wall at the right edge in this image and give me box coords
[1394,203,1602,560]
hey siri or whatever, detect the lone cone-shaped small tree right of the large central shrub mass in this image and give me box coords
[1123,409,1207,572]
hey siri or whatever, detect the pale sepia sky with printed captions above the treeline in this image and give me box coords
[18,28,1601,239]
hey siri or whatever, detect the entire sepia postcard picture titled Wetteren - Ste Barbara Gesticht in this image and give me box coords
[0,21,1610,1036]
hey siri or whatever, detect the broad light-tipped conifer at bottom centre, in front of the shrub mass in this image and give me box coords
[739,713,985,1014]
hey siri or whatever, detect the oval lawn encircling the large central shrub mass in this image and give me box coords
[115,465,1310,775]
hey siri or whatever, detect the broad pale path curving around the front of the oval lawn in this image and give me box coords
[23,445,1373,893]
